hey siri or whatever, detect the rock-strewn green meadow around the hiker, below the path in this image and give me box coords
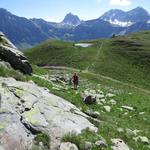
[30,66,150,150]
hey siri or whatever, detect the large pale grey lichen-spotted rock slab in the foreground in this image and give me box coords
[0,78,97,150]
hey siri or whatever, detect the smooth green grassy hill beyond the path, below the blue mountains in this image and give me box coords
[25,31,150,89]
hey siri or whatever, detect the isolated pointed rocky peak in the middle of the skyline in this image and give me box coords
[61,12,81,26]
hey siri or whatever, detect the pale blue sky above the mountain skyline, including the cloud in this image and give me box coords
[0,0,150,22]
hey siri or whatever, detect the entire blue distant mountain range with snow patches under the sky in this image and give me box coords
[0,7,150,49]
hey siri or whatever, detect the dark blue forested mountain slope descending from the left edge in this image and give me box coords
[0,9,48,47]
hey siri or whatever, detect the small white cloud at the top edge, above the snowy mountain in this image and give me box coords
[110,0,132,6]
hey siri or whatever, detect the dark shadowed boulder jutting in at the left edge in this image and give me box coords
[0,33,32,74]
